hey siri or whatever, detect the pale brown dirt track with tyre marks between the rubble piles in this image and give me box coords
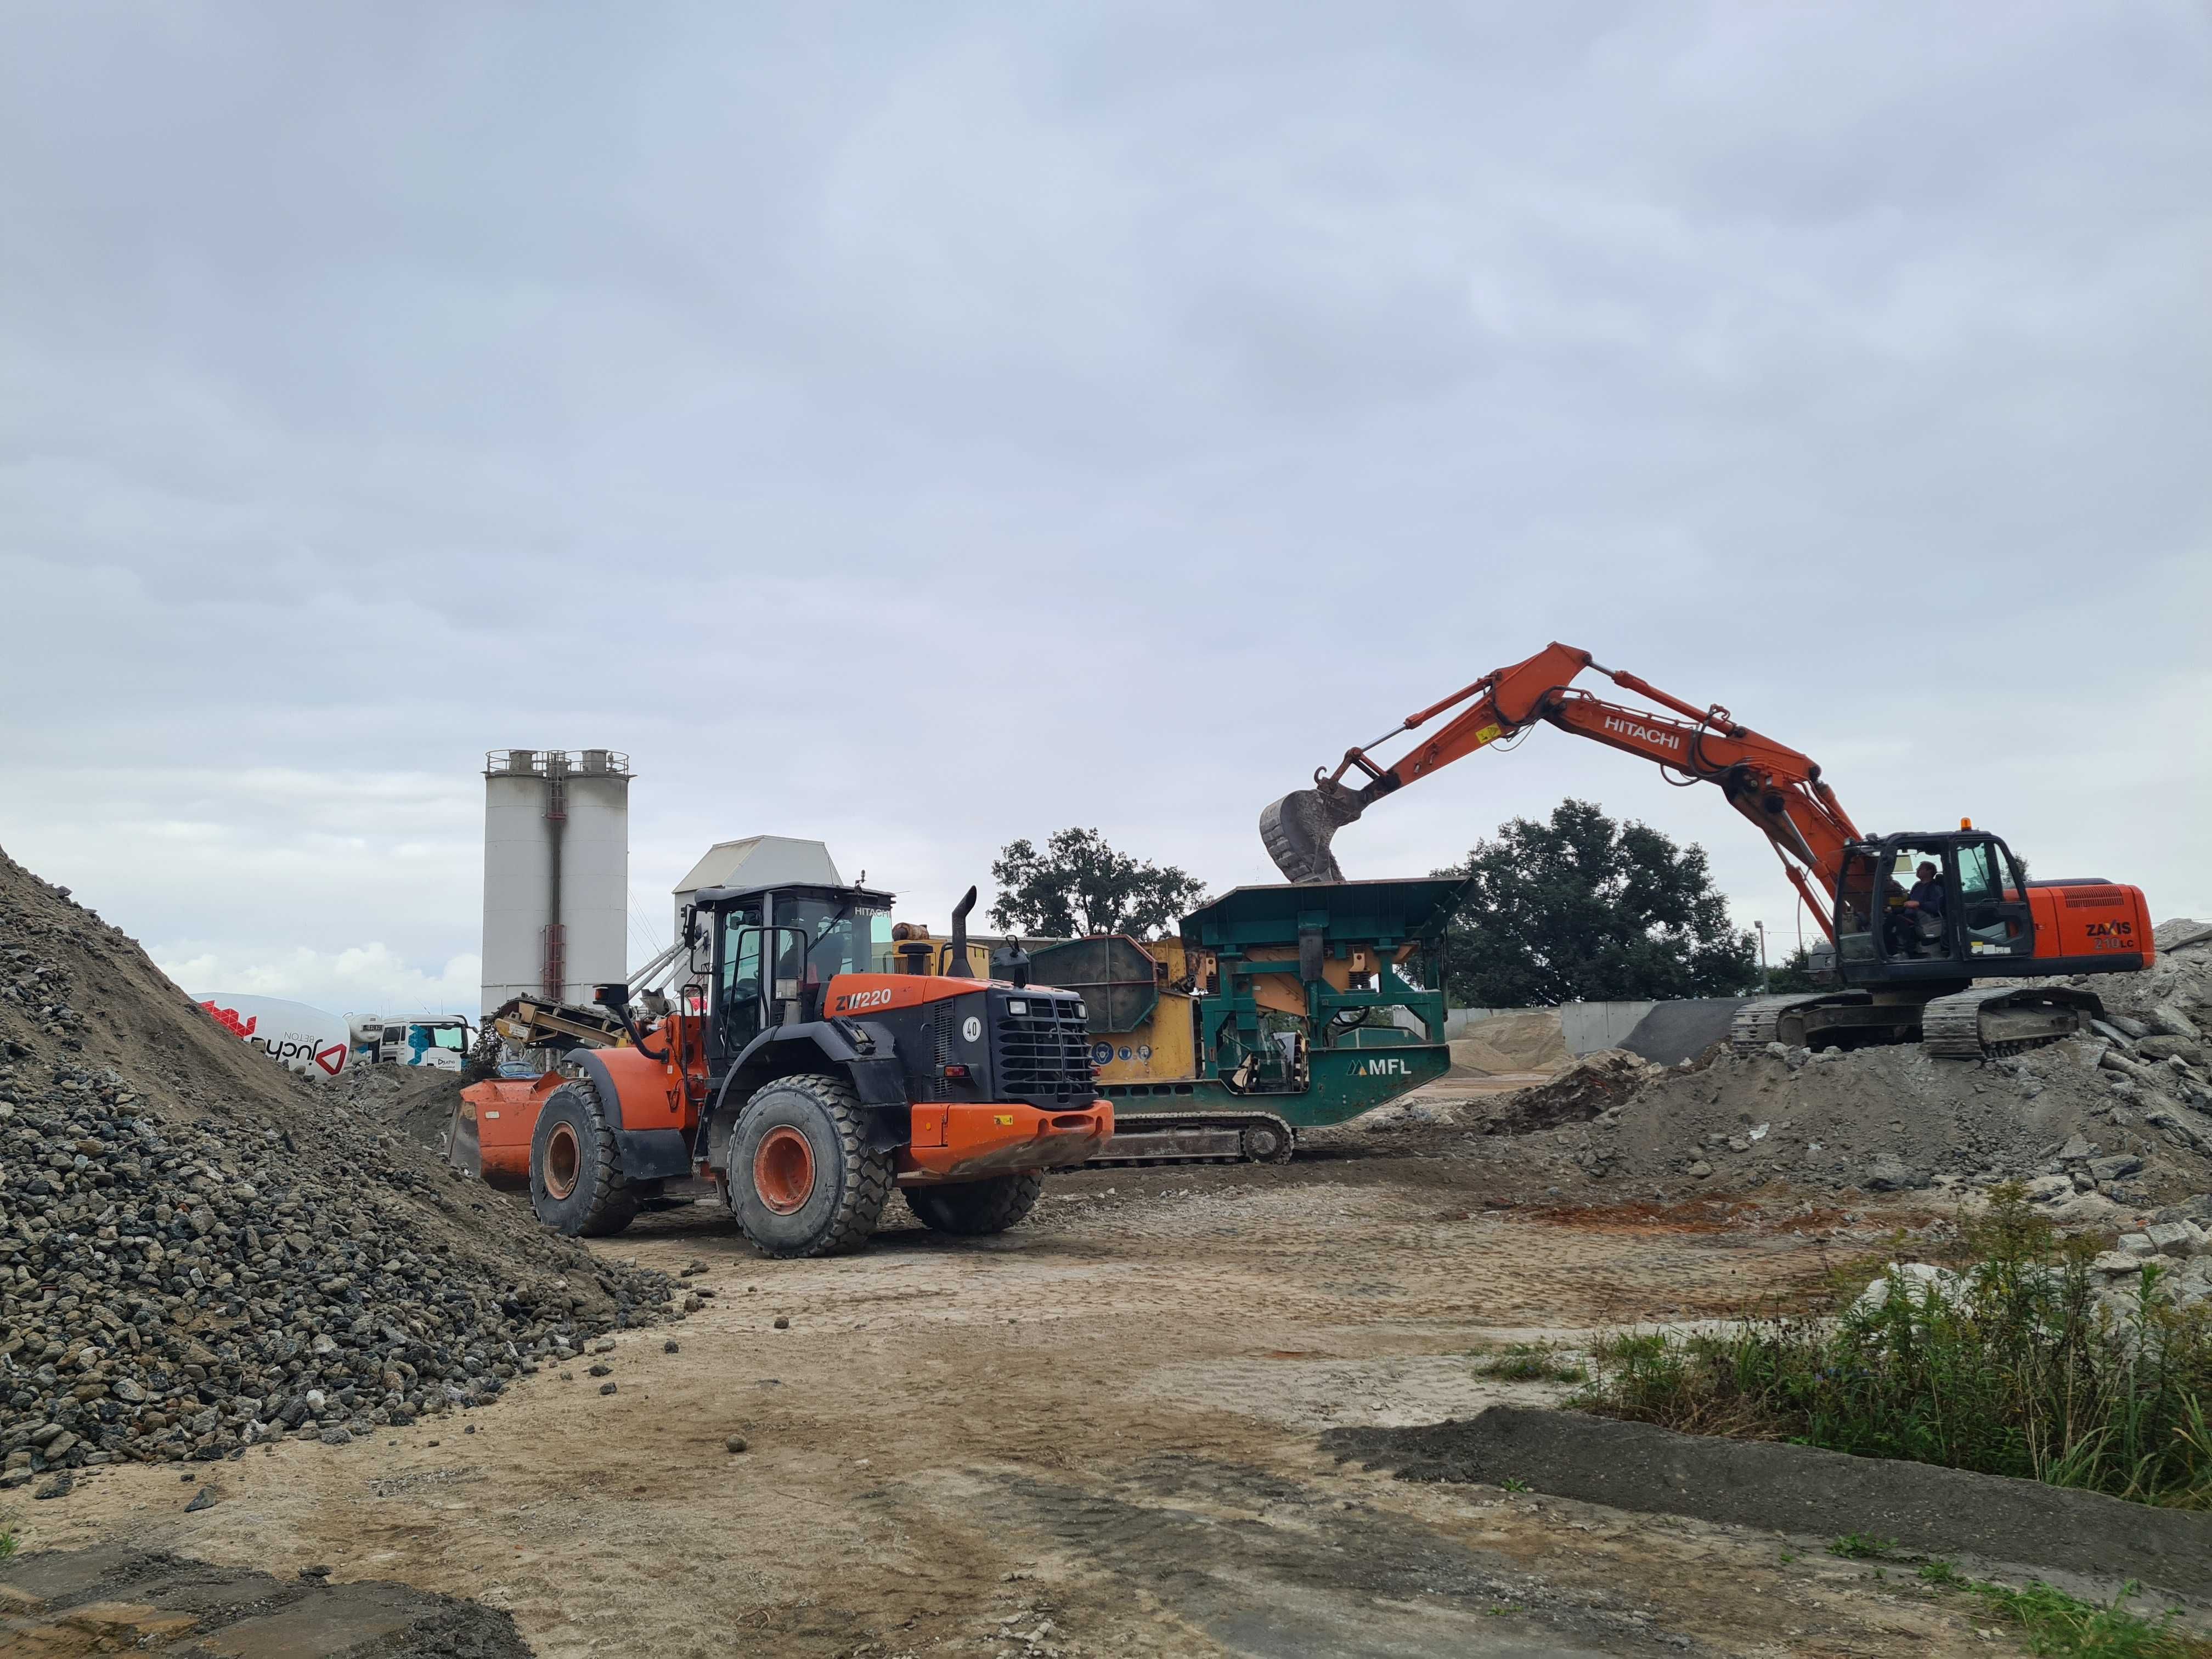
[18,1157,2026,1659]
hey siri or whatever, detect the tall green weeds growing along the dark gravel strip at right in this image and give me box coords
[1575,1186,2212,1509]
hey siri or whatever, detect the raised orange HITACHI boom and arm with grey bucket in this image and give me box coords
[1259,644,1860,929]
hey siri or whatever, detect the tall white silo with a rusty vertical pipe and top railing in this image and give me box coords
[482,750,630,1013]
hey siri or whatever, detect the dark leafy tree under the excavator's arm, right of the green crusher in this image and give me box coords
[1438,801,1758,1009]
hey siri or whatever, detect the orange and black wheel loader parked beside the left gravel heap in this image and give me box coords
[447,885,1113,1256]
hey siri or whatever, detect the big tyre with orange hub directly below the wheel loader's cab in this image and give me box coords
[728,1073,894,1259]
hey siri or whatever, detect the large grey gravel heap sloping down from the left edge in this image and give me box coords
[0,856,681,1498]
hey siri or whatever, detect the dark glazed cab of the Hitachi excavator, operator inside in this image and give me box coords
[1836,830,2035,984]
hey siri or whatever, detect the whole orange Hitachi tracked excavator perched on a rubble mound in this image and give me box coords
[1259,644,2154,1059]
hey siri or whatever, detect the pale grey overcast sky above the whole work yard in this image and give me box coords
[0,0,2212,1011]
